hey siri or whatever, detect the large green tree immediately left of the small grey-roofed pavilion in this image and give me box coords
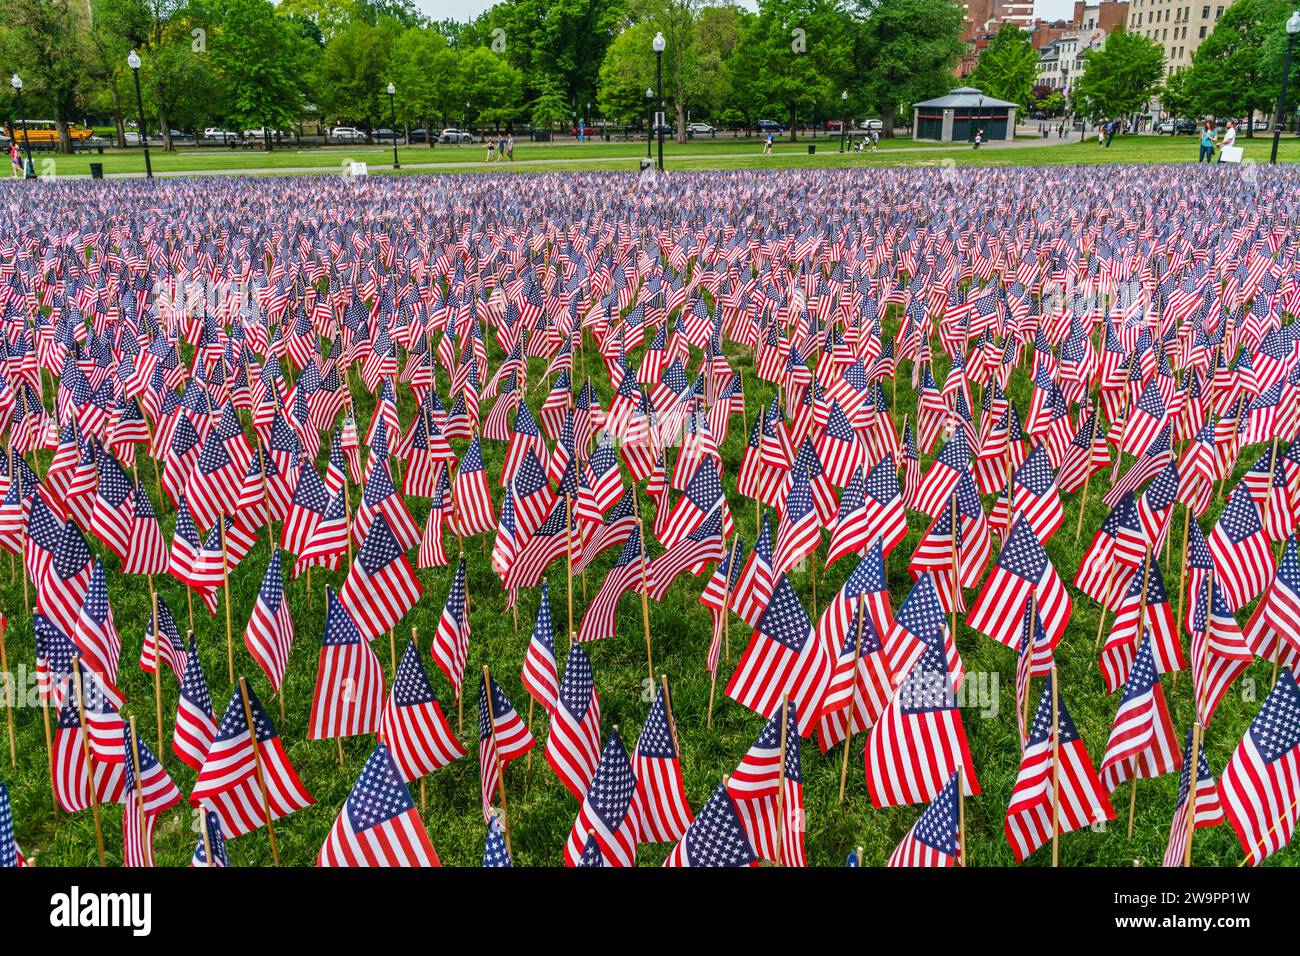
[845,0,962,138]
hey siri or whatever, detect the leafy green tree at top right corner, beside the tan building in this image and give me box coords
[1187,0,1294,135]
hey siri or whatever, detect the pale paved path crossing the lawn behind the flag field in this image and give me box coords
[78,127,1079,179]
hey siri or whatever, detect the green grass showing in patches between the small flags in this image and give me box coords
[0,295,1295,866]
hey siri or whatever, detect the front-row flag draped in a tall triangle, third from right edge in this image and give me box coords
[1002,669,1115,862]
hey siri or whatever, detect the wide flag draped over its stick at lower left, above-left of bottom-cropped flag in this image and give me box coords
[190,680,315,838]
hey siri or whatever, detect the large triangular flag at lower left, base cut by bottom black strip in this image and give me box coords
[316,744,439,866]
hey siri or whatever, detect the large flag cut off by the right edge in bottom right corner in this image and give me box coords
[1219,669,1300,866]
